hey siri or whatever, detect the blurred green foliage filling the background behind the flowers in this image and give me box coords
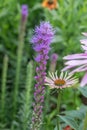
[0,0,87,130]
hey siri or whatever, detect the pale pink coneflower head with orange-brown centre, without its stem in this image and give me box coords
[45,71,78,89]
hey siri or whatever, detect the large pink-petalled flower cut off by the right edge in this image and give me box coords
[63,33,87,87]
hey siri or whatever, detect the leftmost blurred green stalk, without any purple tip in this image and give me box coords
[1,55,8,120]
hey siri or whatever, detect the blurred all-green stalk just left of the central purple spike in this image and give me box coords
[23,62,33,130]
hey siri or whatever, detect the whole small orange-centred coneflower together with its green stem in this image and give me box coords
[45,71,78,130]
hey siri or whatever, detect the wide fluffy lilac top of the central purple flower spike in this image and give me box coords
[32,22,54,49]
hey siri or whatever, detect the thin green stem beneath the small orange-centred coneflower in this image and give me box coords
[57,90,61,130]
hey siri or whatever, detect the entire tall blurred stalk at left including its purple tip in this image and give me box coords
[13,5,28,122]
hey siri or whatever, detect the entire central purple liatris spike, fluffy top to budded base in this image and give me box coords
[32,22,54,130]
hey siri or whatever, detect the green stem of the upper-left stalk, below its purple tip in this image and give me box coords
[13,15,26,118]
